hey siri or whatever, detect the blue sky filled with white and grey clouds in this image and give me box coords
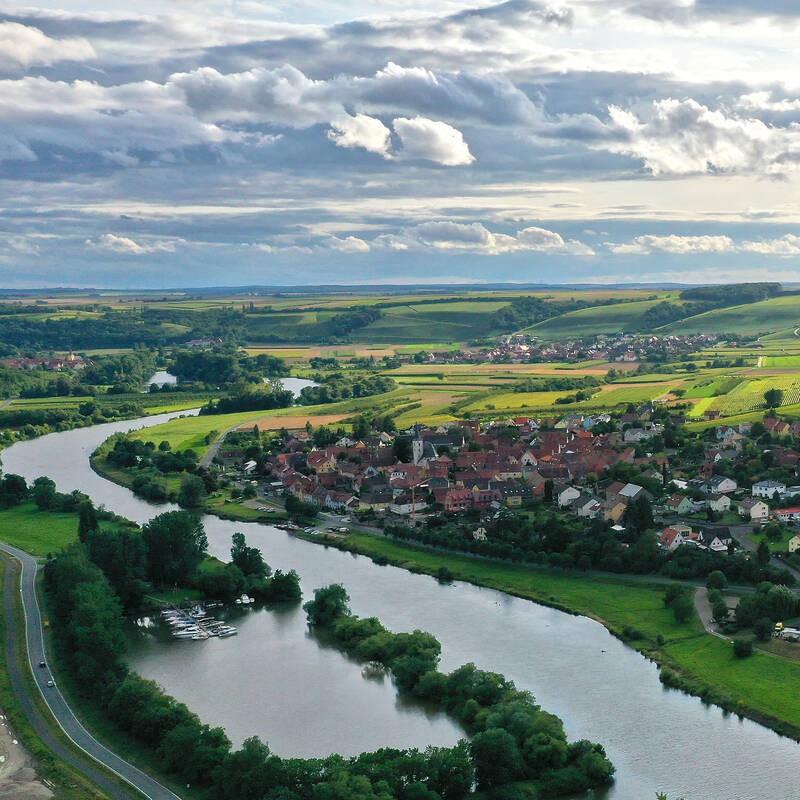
[0,0,800,288]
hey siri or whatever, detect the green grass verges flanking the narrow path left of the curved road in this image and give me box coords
[0,559,121,800]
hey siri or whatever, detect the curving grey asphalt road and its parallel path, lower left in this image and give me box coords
[0,543,180,800]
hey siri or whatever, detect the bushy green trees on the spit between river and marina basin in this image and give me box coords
[303,584,614,798]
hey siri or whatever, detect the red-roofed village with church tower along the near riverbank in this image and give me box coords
[218,403,800,583]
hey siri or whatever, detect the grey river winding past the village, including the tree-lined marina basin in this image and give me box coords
[2,415,800,800]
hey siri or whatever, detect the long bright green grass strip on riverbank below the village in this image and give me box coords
[322,532,800,739]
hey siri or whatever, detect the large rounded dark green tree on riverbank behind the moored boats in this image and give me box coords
[142,511,208,585]
